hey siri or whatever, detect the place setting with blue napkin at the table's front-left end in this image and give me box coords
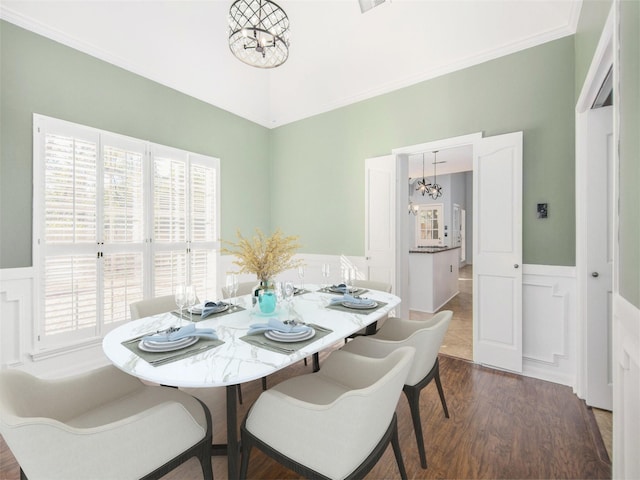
[122,323,224,366]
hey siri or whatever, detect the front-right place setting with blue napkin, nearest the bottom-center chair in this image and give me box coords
[241,318,333,354]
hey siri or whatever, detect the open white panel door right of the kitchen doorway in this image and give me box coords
[473,132,522,372]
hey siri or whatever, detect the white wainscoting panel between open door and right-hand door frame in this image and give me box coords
[522,265,577,387]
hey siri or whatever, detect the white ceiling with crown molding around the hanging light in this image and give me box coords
[0,0,582,128]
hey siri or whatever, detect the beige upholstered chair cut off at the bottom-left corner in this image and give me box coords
[0,366,213,480]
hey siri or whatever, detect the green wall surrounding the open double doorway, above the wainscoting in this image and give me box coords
[271,37,575,265]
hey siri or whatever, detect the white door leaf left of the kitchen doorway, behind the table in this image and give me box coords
[365,155,397,292]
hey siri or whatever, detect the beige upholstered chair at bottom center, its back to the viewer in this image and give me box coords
[240,348,414,479]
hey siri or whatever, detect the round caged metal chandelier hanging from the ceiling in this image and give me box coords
[229,0,289,68]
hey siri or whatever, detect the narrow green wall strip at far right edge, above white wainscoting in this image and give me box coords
[618,0,640,308]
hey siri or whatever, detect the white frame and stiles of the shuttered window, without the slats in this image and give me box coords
[32,114,220,355]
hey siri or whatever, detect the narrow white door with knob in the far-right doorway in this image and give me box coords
[585,107,614,410]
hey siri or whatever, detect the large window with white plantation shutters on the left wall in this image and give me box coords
[34,115,219,349]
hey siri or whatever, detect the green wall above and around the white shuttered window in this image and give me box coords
[0,21,271,268]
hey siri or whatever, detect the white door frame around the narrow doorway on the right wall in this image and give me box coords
[575,6,618,398]
